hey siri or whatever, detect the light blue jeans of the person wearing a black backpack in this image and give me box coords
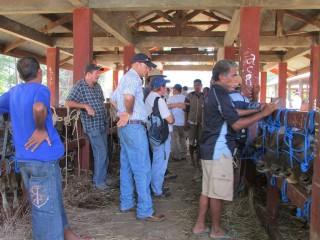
[150,135,170,195]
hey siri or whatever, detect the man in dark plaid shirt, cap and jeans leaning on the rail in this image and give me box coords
[65,64,110,191]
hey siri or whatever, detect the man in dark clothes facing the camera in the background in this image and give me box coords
[185,79,203,168]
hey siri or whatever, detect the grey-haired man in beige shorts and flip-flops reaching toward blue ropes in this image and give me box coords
[192,60,277,239]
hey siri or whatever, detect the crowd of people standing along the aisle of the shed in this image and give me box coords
[0,53,277,240]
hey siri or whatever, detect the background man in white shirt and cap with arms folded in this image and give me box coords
[167,84,187,161]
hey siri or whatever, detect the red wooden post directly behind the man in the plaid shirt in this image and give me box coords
[73,8,93,169]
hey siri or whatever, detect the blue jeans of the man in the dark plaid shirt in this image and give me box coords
[87,130,109,186]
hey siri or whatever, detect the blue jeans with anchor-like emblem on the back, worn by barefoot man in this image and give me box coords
[19,160,68,240]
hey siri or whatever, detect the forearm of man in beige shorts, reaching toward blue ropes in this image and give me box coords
[231,103,279,131]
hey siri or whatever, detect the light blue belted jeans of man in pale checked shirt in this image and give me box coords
[118,124,154,218]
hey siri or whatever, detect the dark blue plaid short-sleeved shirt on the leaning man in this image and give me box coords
[66,79,107,132]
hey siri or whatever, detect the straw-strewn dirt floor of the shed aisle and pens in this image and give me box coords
[0,155,308,240]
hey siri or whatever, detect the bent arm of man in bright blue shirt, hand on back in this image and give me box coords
[24,102,51,152]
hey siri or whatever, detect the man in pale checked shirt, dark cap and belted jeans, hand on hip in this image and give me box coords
[111,53,165,222]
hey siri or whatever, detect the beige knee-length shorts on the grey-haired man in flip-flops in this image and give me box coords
[201,154,233,201]
